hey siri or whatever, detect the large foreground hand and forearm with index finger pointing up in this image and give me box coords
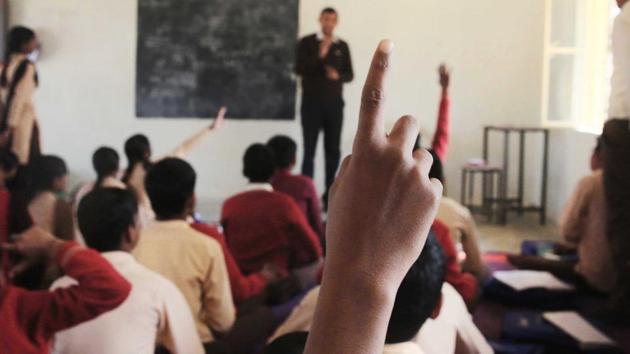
[305,41,442,354]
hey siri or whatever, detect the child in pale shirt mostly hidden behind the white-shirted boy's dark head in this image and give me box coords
[73,146,127,244]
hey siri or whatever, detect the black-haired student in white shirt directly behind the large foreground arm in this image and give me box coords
[265,232,492,354]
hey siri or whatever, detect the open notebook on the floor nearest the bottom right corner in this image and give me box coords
[543,311,616,350]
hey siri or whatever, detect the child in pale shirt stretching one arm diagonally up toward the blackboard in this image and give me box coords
[122,107,227,227]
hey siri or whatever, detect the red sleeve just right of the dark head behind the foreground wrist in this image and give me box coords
[432,220,477,305]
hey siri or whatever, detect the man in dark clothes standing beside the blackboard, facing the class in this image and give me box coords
[296,8,354,208]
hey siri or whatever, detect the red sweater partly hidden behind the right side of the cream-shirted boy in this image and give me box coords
[191,223,267,303]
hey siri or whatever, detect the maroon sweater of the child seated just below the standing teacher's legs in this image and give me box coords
[271,171,324,237]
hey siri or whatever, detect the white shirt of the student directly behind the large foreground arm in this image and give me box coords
[268,283,493,354]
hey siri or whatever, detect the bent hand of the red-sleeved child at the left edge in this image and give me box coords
[0,227,63,278]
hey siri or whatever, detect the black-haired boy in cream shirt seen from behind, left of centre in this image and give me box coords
[133,158,236,352]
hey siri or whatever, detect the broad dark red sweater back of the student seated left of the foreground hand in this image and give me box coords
[221,190,322,274]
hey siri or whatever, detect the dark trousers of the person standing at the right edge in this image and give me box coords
[602,119,630,316]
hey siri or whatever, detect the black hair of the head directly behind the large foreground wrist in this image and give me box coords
[385,232,445,344]
